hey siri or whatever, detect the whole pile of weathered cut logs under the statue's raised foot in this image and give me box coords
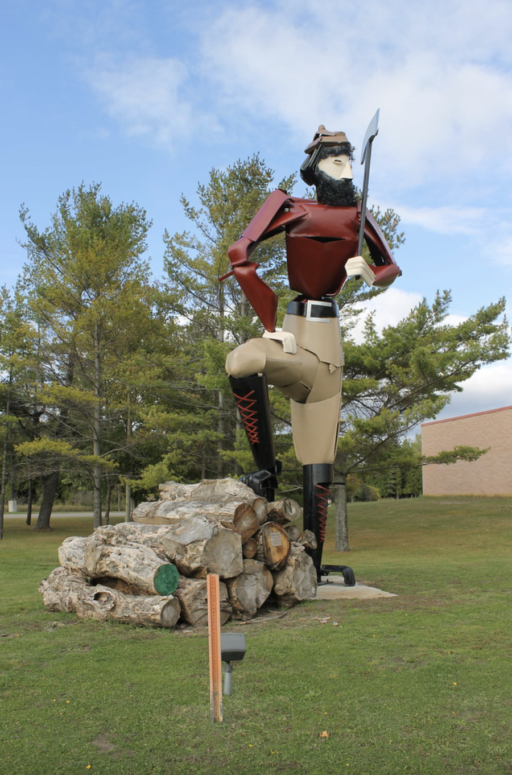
[39,479,317,627]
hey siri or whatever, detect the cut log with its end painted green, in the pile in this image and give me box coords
[85,536,179,596]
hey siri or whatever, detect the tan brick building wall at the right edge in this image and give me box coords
[421,406,512,495]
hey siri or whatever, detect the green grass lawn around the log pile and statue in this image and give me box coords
[0,498,512,775]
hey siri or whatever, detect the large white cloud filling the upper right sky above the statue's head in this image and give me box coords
[199,0,512,187]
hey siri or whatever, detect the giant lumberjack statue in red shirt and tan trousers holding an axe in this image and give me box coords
[221,112,401,583]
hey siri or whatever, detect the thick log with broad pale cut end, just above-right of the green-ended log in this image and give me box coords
[163,517,243,579]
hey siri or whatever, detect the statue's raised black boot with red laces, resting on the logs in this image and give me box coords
[229,374,281,501]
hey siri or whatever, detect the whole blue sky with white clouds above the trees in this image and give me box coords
[0,0,512,417]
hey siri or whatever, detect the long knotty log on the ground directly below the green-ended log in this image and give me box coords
[39,568,180,628]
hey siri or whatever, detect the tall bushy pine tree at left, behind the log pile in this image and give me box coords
[14,184,158,527]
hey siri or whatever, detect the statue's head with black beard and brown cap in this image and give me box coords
[300,124,357,206]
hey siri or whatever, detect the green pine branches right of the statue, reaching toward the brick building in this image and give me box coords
[337,291,509,488]
